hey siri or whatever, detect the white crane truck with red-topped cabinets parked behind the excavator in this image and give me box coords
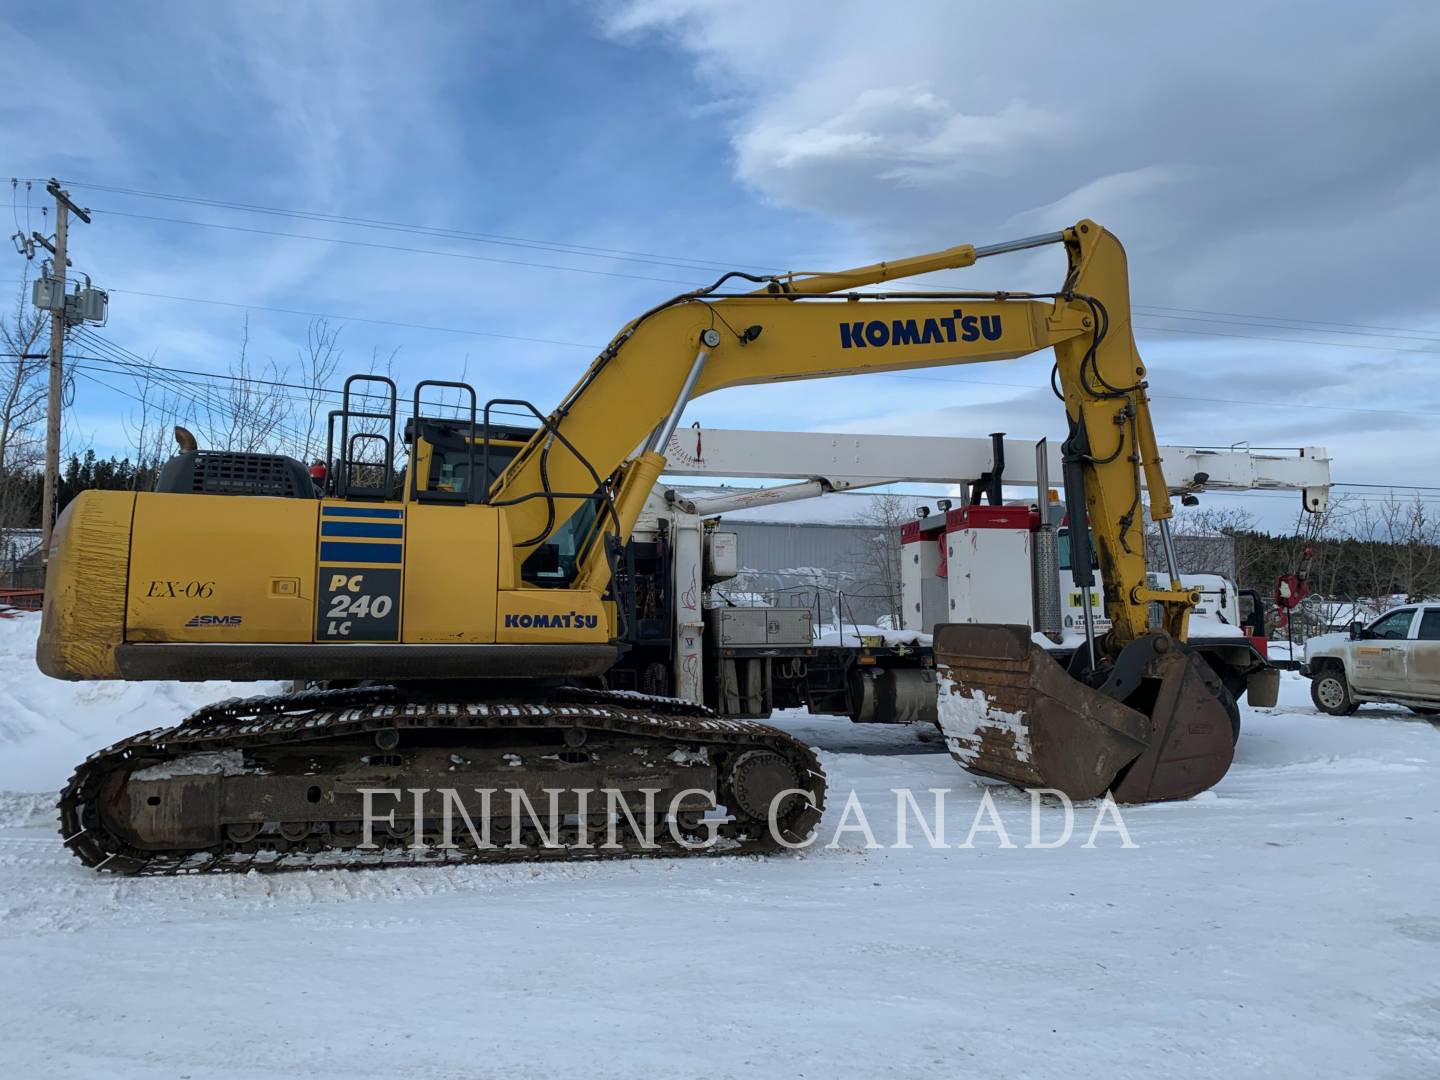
[624,428,1329,723]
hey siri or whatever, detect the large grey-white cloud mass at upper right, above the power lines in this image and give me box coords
[608,0,1440,321]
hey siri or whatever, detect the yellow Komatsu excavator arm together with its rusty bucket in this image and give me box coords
[491,220,1238,802]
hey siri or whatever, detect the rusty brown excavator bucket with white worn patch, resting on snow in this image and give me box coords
[935,624,1234,802]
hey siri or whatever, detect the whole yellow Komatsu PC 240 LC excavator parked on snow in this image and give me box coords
[37,220,1233,873]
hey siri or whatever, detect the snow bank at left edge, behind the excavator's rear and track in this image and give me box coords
[0,613,281,792]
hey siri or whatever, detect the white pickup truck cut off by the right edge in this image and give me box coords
[1300,603,1440,716]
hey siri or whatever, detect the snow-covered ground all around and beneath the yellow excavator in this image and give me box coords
[0,618,1440,1080]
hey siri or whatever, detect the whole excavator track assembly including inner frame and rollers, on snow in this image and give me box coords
[59,687,825,874]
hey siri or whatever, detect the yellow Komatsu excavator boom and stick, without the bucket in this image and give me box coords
[491,222,1192,648]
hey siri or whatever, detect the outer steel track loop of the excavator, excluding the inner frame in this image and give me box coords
[59,687,825,874]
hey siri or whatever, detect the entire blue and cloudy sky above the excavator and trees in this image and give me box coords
[0,0,1440,524]
